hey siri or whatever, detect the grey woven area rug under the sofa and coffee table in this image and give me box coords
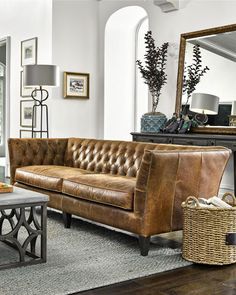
[0,210,191,295]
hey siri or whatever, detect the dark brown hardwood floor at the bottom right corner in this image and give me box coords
[75,265,236,295]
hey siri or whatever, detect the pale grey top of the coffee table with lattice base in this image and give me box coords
[0,186,49,206]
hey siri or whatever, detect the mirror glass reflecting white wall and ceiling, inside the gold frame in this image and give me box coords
[182,32,236,125]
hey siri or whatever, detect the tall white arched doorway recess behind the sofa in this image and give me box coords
[104,6,148,140]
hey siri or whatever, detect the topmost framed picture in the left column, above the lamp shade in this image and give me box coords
[21,37,37,67]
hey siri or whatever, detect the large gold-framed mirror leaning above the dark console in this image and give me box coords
[175,24,236,134]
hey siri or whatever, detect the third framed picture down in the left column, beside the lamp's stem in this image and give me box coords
[20,100,36,127]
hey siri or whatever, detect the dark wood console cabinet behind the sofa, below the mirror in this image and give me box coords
[131,132,236,194]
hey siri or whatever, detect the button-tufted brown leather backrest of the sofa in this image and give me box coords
[65,138,215,177]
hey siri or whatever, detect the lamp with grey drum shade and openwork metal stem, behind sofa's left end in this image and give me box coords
[23,65,59,138]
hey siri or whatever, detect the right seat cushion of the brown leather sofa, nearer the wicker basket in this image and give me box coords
[62,174,136,210]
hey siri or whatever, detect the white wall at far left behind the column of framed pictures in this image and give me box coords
[0,0,52,137]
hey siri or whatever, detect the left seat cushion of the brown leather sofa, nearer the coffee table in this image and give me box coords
[15,165,91,192]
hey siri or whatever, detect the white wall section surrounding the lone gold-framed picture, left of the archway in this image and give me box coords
[51,0,99,137]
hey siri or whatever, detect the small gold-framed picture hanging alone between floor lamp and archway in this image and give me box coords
[64,72,89,98]
